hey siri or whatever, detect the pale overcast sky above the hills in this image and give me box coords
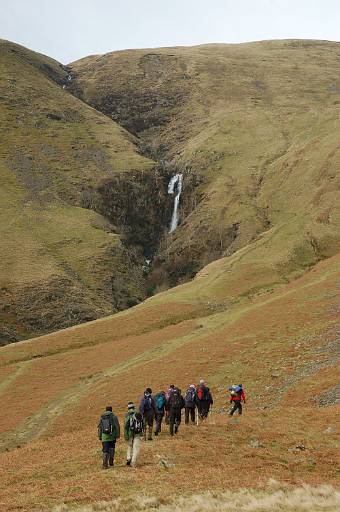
[0,0,340,64]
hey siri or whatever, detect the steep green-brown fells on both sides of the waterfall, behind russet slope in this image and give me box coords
[5,41,340,342]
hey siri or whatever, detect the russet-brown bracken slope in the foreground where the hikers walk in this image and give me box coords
[0,247,340,512]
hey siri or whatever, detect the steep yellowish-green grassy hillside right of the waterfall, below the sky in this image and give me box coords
[70,40,340,296]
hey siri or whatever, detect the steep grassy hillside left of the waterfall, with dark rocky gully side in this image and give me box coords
[0,41,170,344]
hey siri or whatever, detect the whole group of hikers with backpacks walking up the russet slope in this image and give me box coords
[98,379,246,469]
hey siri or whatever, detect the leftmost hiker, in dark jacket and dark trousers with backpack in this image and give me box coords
[98,405,120,469]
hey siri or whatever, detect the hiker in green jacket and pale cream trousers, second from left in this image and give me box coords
[124,402,144,468]
